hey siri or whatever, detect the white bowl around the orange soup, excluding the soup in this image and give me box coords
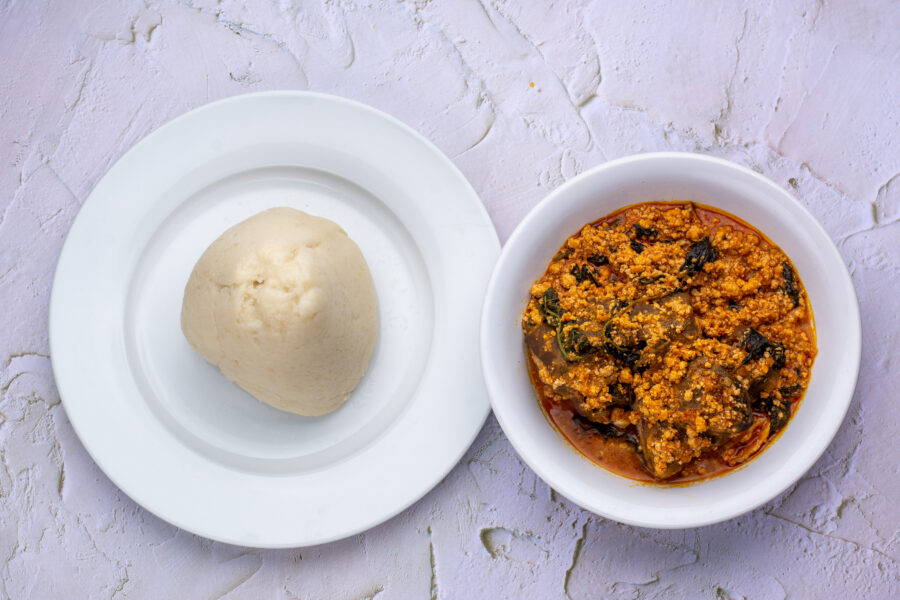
[481,153,861,528]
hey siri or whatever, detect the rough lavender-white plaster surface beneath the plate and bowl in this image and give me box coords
[0,0,900,600]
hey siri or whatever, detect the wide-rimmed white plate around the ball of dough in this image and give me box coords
[50,92,499,547]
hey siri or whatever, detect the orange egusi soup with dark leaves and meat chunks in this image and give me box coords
[522,202,816,482]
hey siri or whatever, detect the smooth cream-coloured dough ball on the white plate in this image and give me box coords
[181,208,378,416]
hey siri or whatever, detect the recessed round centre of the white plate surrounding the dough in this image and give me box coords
[125,166,434,473]
